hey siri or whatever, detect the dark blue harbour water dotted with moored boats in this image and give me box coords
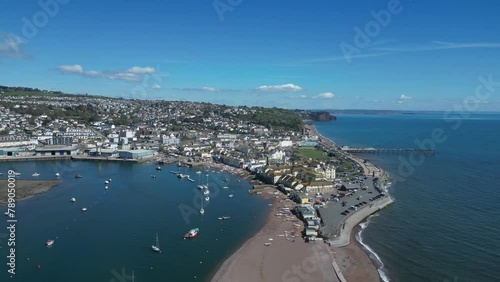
[0,161,269,282]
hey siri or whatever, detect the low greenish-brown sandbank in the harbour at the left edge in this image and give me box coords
[0,180,61,206]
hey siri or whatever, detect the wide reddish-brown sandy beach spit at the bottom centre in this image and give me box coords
[211,190,340,282]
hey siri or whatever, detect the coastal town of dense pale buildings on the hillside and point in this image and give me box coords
[0,88,392,281]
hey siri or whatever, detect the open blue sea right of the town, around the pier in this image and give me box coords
[316,114,500,282]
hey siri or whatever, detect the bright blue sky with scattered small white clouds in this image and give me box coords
[0,0,500,111]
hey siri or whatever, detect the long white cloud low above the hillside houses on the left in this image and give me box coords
[56,65,156,82]
